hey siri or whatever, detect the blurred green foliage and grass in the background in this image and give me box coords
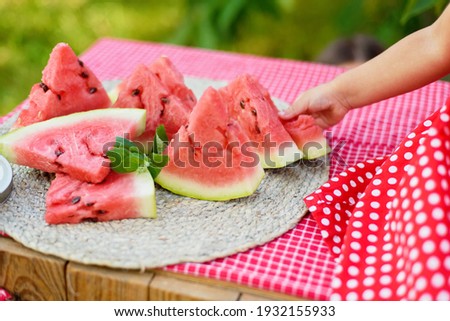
[0,0,448,116]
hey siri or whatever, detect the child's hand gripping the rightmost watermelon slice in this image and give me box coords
[279,83,351,128]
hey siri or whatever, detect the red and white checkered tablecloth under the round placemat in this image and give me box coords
[0,39,450,300]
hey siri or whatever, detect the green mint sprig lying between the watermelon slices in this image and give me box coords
[106,125,169,179]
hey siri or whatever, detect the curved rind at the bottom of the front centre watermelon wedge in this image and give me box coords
[155,166,265,201]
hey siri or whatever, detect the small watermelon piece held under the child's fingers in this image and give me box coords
[281,115,330,159]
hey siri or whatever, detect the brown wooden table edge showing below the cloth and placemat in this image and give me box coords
[0,237,299,301]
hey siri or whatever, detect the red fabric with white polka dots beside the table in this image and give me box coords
[305,99,450,300]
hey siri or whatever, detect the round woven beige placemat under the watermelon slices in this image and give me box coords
[0,78,328,269]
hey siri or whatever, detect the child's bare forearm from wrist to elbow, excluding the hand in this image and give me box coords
[330,17,450,108]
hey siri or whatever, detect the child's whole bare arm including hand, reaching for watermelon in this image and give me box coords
[280,6,450,127]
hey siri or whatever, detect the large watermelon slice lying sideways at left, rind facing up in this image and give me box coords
[0,108,145,183]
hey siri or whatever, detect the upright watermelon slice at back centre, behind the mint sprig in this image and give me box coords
[113,57,196,150]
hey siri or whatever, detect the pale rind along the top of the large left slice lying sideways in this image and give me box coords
[0,108,146,163]
